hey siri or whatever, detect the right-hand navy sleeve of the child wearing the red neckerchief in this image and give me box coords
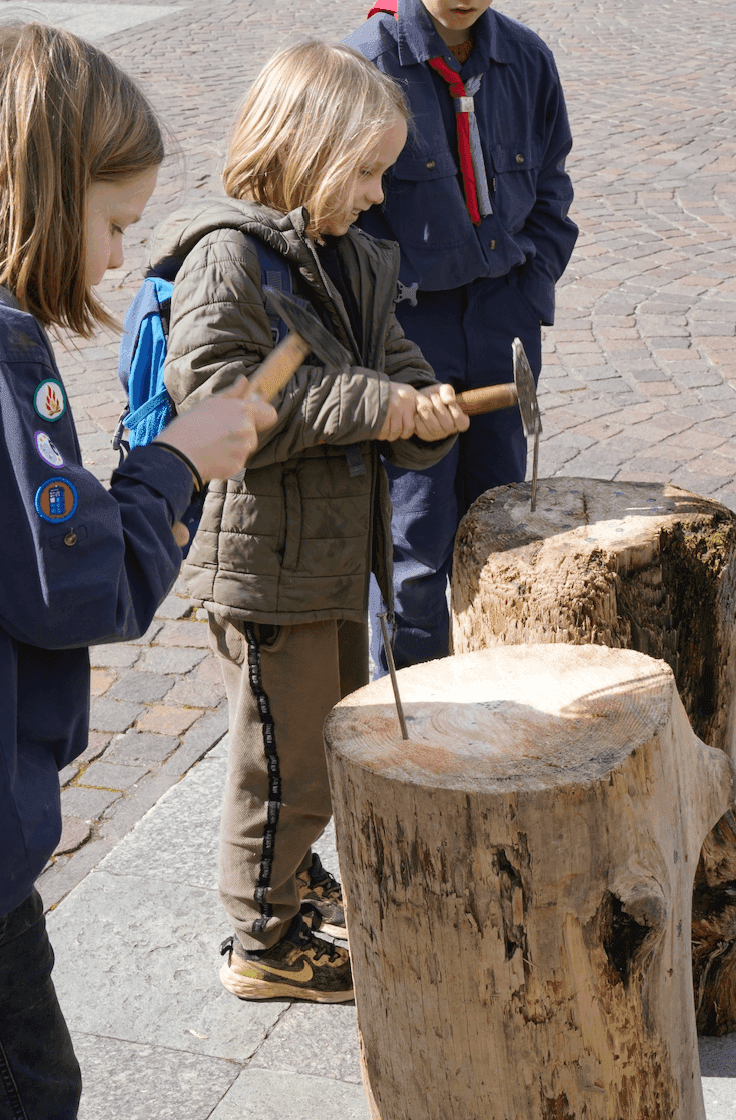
[520,58,578,326]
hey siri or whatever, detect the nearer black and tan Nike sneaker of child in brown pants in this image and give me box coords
[220,914,354,1004]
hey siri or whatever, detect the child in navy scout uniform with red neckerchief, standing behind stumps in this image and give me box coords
[345,0,577,672]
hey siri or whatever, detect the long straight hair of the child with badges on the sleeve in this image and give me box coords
[0,24,165,338]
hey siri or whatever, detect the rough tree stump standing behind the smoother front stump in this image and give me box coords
[453,478,736,1035]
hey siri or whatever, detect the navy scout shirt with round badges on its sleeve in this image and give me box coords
[0,289,192,916]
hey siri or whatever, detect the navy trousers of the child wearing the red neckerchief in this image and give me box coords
[370,273,541,676]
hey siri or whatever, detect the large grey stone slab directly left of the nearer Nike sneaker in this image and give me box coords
[48,869,289,1064]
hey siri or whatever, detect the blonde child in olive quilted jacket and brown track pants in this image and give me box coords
[150,41,467,1002]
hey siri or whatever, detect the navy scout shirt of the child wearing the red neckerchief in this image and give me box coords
[344,0,577,324]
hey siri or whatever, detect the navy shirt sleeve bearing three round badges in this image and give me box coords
[0,312,192,650]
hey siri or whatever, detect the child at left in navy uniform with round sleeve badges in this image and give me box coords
[0,24,276,1120]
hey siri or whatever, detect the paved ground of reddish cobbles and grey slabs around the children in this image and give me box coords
[7,0,736,1120]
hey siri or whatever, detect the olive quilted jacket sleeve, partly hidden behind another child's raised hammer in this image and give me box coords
[165,230,405,468]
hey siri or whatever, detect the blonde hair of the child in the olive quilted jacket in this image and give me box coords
[223,40,409,233]
